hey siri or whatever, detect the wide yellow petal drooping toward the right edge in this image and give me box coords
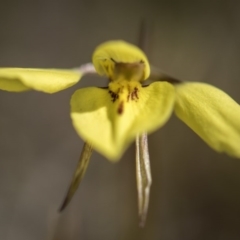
[175,83,240,158]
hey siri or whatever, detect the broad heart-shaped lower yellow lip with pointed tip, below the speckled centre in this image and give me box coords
[71,82,175,160]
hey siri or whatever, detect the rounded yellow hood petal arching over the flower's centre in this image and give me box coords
[92,41,150,80]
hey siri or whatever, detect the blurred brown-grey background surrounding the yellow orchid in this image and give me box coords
[0,0,240,240]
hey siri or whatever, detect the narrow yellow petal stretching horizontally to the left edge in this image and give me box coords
[0,68,81,93]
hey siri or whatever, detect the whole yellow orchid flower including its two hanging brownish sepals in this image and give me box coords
[0,41,240,225]
